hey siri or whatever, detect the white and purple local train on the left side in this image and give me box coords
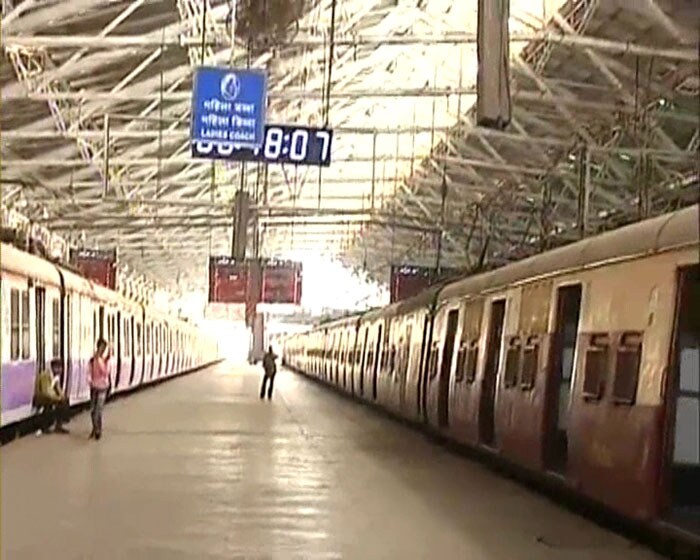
[0,243,218,428]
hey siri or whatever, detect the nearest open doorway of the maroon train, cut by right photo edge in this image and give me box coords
[666,265,700,529]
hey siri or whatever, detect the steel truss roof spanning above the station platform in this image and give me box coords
[0,0,700,294]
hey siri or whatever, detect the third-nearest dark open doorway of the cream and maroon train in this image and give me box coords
[479,299,506,446]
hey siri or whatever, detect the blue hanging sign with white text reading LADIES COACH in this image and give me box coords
[190,66,267,147]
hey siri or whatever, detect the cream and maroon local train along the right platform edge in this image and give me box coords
[281,205,700,531]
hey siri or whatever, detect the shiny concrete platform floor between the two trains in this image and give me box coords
[0,364,656,560]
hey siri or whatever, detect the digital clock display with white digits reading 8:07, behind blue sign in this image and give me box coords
[192,124,333,167]
